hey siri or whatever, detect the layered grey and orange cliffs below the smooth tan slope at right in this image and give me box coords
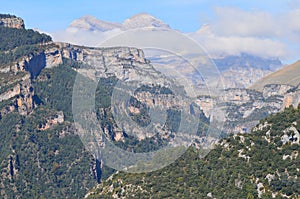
[198,84,300,133]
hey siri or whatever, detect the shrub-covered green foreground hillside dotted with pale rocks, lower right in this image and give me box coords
[86,107,300,199]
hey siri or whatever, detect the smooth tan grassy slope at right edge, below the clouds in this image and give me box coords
[250,61,300,91]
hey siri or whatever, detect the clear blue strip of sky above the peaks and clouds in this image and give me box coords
[0,0,292,32]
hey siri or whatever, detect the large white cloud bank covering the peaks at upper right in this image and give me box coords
[190,7,300,60]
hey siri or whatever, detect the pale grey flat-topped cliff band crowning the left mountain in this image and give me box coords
[59,43,151,80]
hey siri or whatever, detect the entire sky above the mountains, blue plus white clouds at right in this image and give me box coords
[0,0,300,62]
